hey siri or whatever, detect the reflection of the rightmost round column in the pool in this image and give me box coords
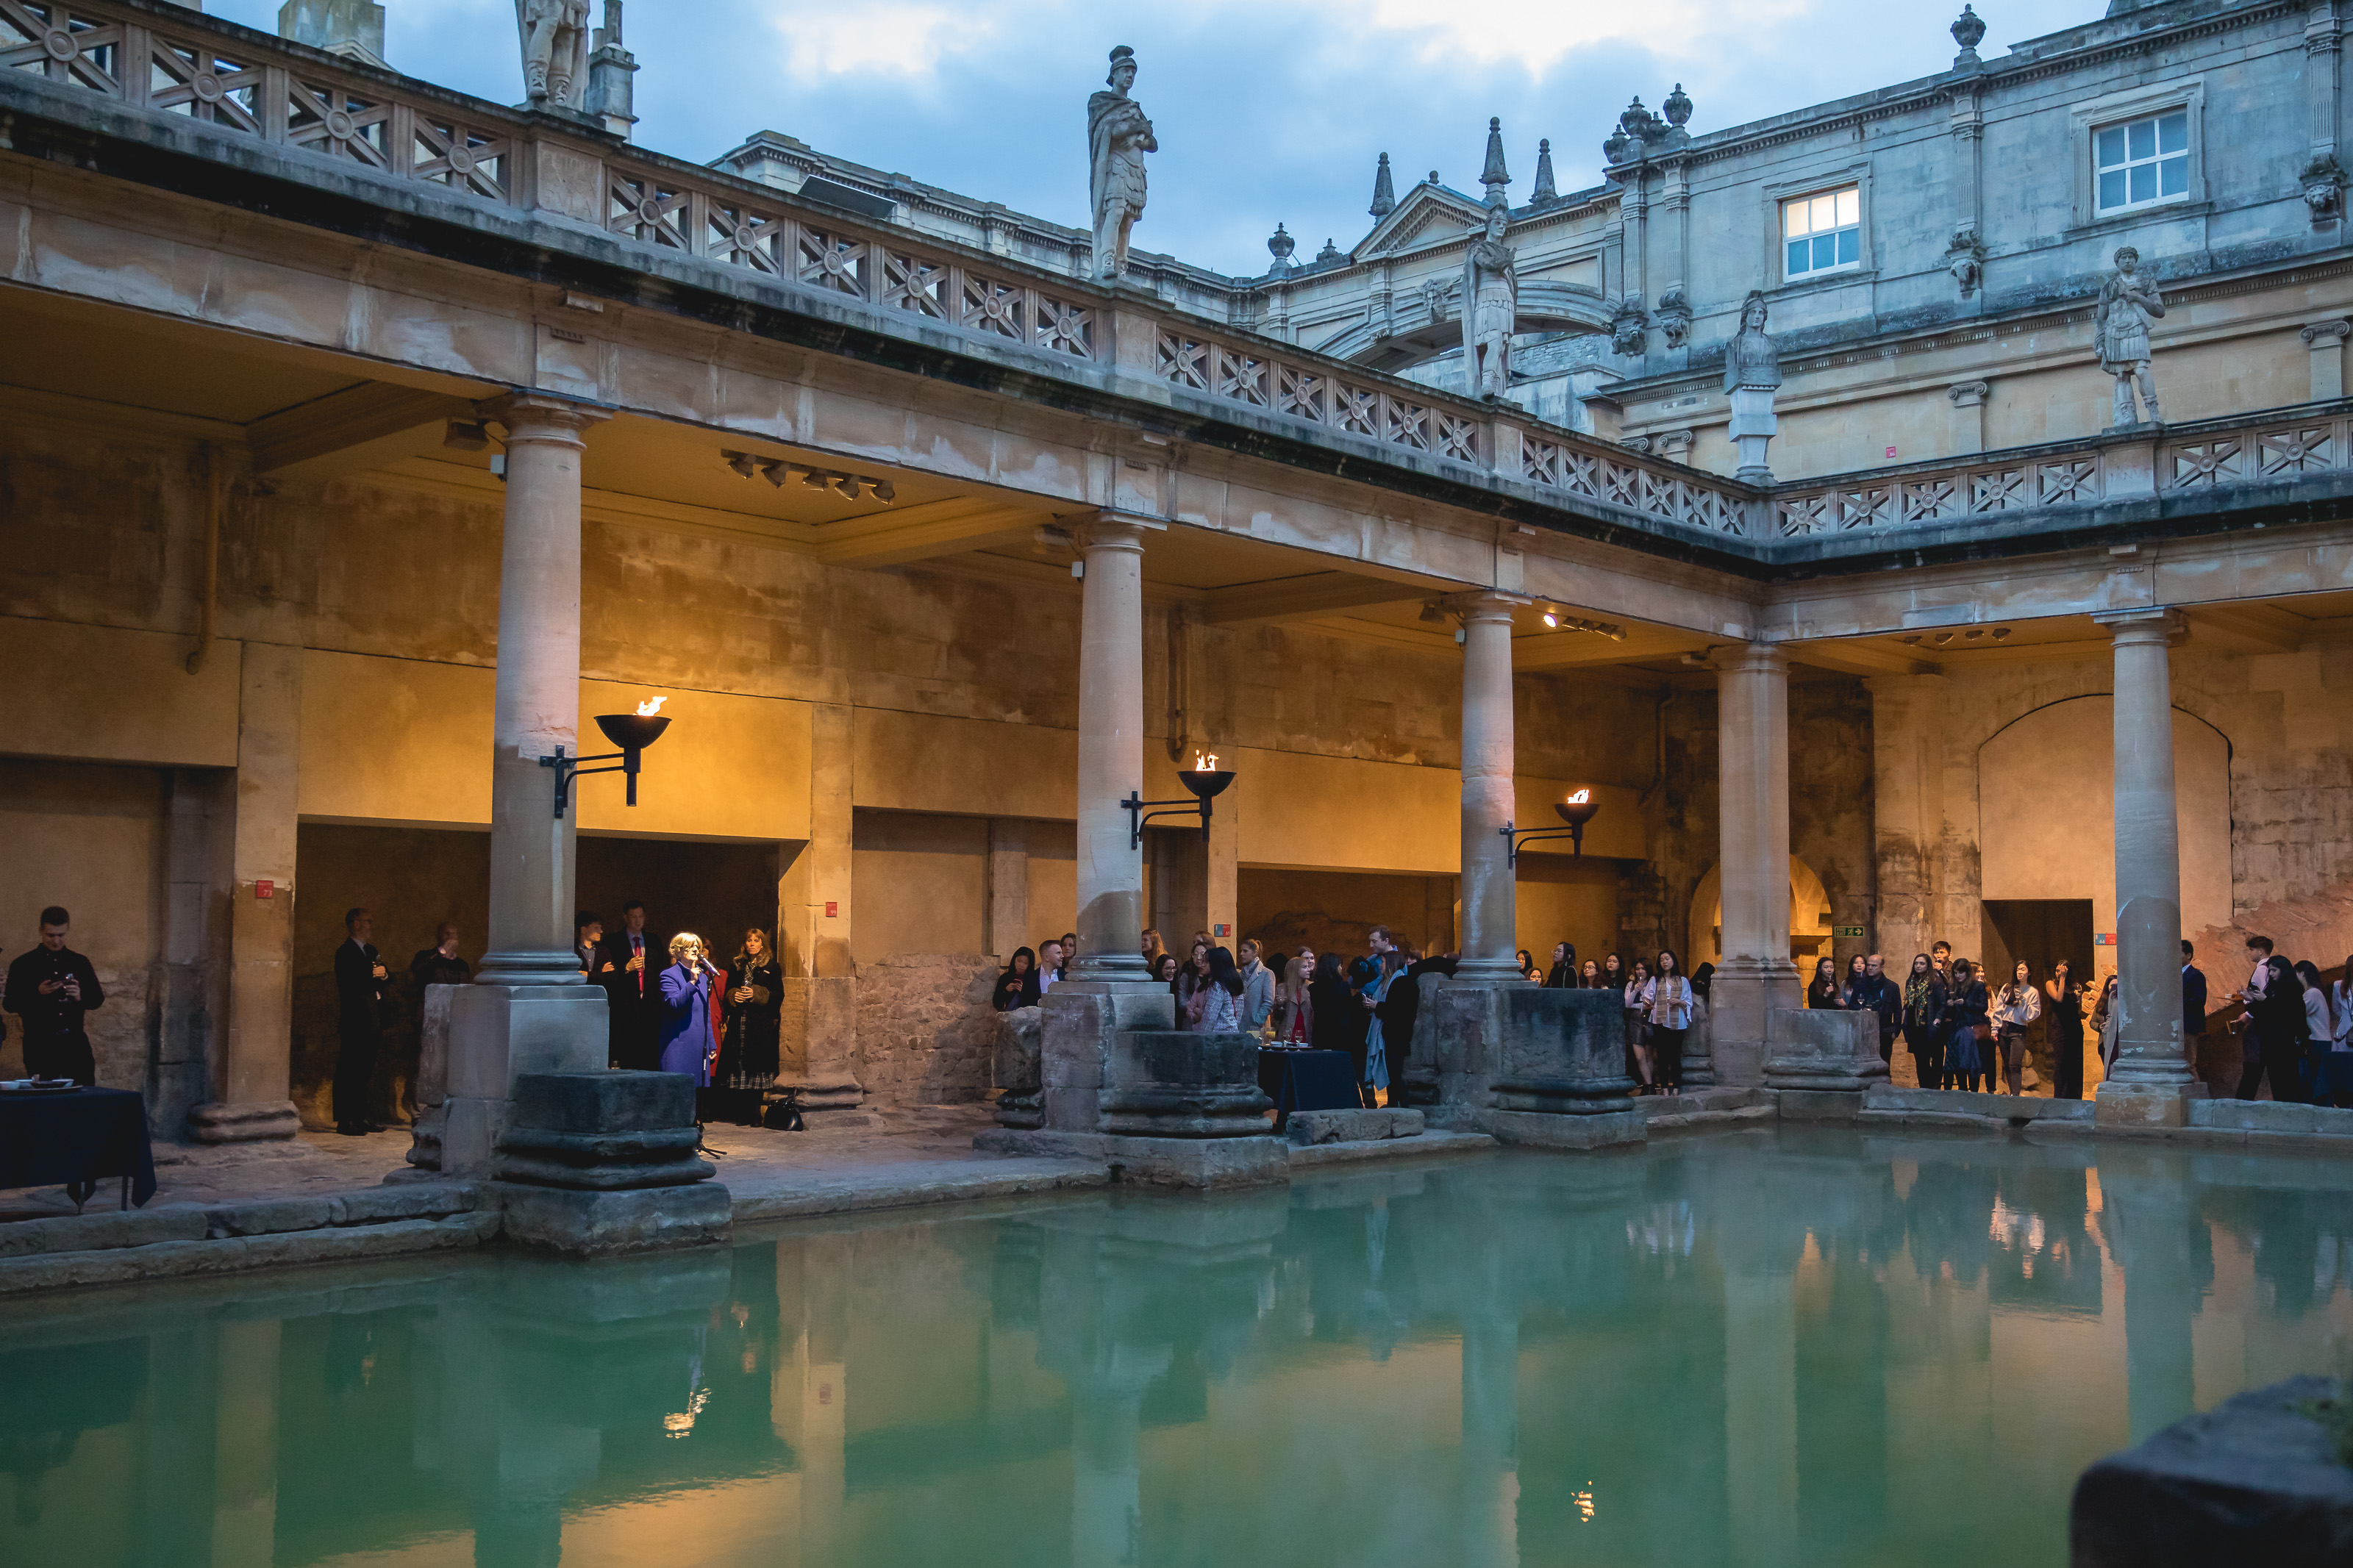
[2099,1159,2212,1444]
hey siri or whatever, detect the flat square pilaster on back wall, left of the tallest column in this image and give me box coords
[188,642,304,1142]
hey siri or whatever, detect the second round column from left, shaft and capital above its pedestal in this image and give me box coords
[1071,512,1157,983]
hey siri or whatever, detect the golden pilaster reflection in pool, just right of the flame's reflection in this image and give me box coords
[769,1236,854,1568]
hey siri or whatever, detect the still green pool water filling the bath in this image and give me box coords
[0,1131,2353,1568]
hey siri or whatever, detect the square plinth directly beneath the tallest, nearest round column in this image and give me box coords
[440,983,610,1178]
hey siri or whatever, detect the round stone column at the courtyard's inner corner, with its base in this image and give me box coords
[1708,642,1804,1084]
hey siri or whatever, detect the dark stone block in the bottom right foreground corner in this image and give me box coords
[2068,1378,2353,1568]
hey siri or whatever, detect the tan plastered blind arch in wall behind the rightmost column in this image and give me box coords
[1977,691,2233,945]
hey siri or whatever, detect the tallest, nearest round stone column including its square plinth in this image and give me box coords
[443,393,607,1175]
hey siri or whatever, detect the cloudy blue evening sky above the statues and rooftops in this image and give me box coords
[204,0,2106,273]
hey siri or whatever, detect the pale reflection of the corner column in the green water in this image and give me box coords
[1725,1270,1798,1568]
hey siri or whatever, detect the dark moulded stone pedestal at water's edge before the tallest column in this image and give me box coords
[492,1070,734,1258]
